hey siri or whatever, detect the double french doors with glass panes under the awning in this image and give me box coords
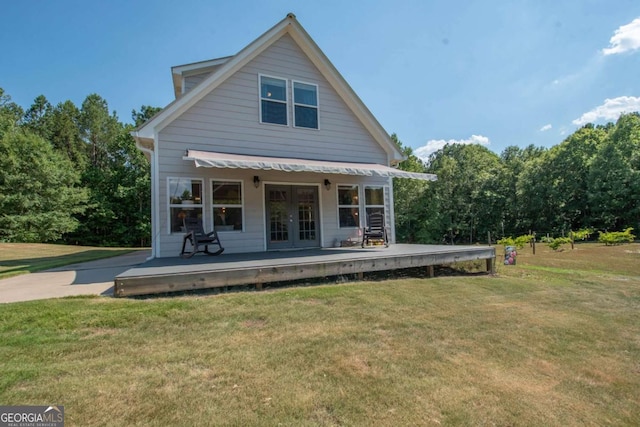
[265,184,320,249]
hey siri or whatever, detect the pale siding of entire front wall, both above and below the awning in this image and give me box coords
[156,35,396,257]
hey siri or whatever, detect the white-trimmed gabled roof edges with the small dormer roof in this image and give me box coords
[132,13,404,164]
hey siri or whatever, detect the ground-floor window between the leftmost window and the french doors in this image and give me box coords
[211,180,244,231]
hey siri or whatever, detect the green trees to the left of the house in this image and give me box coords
[0,88,160,246]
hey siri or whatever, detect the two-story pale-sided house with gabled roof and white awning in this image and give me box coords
[133,14,435,257]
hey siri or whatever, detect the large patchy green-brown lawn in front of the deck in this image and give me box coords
[0,244,640,426]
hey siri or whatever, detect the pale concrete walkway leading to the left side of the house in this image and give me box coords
[0,251,151,303]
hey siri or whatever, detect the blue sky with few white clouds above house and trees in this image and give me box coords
[0,0,640,159]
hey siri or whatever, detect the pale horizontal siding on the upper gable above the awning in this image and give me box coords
[159,35,388,164]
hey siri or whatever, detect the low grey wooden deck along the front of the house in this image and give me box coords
[114,244,496,297]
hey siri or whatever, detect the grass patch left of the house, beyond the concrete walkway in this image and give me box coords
[0,243,134,279]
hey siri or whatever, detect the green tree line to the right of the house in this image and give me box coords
[393,112,640,243]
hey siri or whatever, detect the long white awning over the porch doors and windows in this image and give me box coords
[183,150,438,181]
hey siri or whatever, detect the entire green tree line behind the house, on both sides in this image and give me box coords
[0,88,640,246]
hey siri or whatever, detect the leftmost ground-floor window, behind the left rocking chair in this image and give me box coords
[167,178,203,233]
